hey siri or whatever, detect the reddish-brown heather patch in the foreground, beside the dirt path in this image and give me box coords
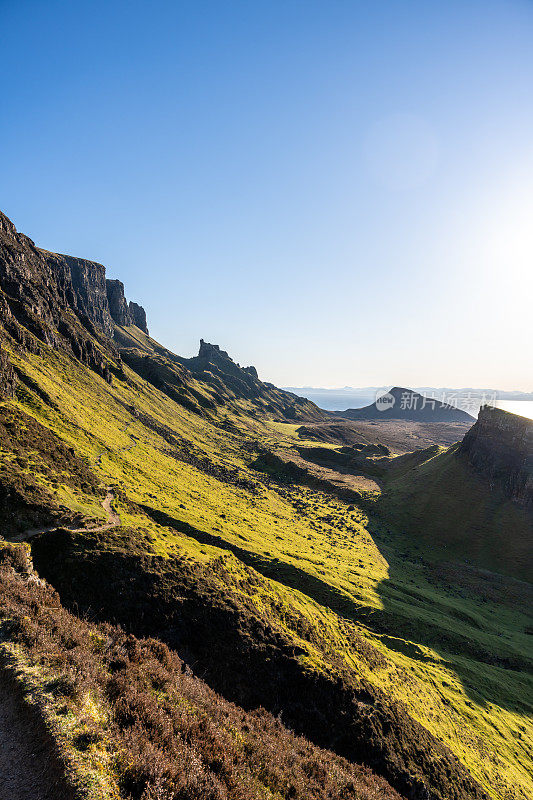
[0,544,400,800]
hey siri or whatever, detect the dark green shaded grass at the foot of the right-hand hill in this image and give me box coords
[368,518,533,714]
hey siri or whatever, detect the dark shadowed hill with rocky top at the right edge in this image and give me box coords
[378,407,533,580]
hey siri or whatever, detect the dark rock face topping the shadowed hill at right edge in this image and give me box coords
[458,406,533,507]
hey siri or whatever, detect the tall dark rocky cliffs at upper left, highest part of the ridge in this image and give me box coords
[0,212,148,392]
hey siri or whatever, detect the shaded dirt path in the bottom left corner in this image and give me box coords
[0,667,76,800]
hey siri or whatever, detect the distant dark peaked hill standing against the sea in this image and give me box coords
[332,386,474,422]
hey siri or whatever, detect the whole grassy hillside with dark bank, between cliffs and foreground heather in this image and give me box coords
[3,332,531,798]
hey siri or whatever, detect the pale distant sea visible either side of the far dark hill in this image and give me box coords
[286,387,533,419]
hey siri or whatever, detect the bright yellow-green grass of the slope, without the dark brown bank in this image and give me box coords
[0,340,533,800]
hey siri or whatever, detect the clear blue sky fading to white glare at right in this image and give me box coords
[0,0,533,390]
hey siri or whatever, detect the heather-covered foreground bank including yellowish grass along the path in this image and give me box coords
[0,545,400,800]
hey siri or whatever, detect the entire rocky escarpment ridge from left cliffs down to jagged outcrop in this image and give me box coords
[0,212,324,421]
